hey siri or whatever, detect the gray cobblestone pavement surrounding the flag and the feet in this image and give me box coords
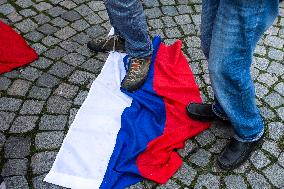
[0,0,284,189]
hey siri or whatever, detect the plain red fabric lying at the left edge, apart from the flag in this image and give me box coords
[0,21,38,74]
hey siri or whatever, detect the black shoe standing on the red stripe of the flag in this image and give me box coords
[186,103,222,122]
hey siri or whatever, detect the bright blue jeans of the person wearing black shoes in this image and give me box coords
[201,0,279,142]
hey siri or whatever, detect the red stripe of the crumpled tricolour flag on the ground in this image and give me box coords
[136,41,209,184]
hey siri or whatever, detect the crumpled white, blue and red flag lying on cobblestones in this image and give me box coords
[45,37,209,189]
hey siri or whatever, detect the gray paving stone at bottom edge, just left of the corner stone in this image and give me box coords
[246,171,271,189]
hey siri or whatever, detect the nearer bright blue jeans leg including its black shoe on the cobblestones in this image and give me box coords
[208,0,278,169]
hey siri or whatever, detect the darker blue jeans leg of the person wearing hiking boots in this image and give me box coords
[104,0,152,57]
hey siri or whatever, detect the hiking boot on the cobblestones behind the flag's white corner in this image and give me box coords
[87,35,125,52]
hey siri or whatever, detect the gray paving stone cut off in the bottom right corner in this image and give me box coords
[263,164,284,188]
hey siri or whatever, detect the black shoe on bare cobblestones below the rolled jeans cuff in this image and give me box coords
[217,138,262,170]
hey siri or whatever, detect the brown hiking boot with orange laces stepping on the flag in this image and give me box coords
[121,55,152,92]
